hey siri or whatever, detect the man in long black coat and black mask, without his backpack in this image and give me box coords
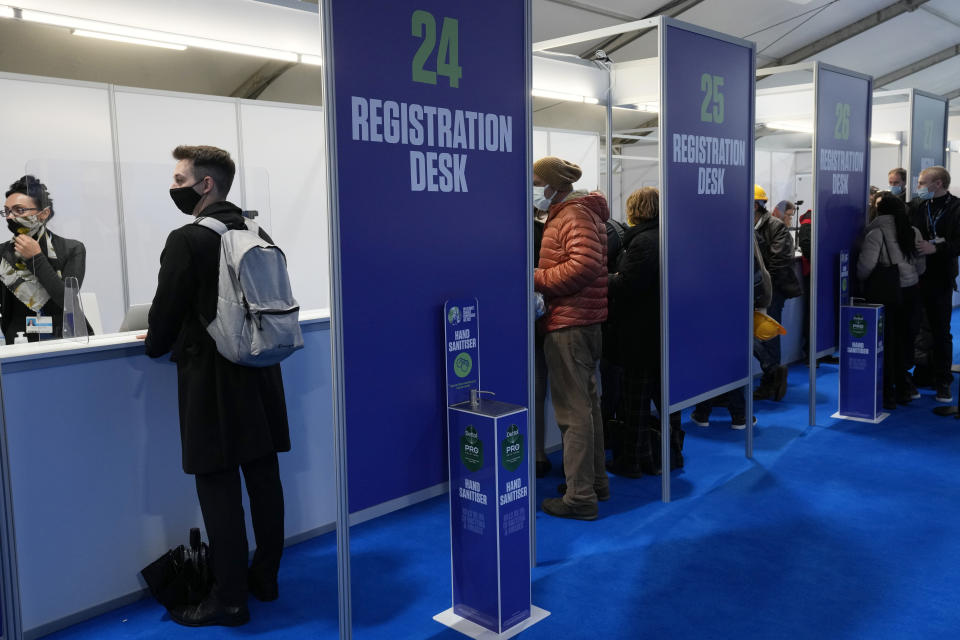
[146,146,290,626]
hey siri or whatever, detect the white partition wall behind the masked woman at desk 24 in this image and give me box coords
[0,74,330,333]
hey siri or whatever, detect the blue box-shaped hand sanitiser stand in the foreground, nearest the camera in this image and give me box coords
[448,401,530,633]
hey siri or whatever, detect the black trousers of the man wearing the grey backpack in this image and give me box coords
[196,453,283,606]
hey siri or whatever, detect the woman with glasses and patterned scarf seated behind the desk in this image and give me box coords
[0,176,87,344]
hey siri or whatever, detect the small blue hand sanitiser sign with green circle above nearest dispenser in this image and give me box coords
[443,298,480,405]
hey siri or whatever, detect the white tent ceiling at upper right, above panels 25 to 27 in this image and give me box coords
[533,0,960,110]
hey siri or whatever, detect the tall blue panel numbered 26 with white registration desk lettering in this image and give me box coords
[813,65,872,354]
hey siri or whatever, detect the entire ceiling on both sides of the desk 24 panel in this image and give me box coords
[0,0,960,112]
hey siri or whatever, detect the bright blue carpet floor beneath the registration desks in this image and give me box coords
[48,317,960,640]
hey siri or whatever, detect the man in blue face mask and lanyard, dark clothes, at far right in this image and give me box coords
[910,166,960,403]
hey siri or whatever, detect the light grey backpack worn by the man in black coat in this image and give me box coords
[195,218,303,367]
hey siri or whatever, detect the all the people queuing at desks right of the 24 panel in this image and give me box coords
[533,157,960,520]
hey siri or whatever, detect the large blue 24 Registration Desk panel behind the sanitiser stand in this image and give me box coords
[329,0,532,511]
